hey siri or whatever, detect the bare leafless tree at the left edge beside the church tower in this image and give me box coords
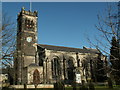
[0,13,16,67]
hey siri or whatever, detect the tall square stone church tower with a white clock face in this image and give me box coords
[14,8,38,84]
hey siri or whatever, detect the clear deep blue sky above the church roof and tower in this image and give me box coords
[2,2,116,48]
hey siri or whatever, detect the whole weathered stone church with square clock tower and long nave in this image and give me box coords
[14,8,105,84]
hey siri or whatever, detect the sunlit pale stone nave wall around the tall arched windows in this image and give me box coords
[44,49,98,83]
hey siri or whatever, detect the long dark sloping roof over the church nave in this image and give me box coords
[38,44,100,53]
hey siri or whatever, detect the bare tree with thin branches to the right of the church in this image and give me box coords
[87,2,120,84]
